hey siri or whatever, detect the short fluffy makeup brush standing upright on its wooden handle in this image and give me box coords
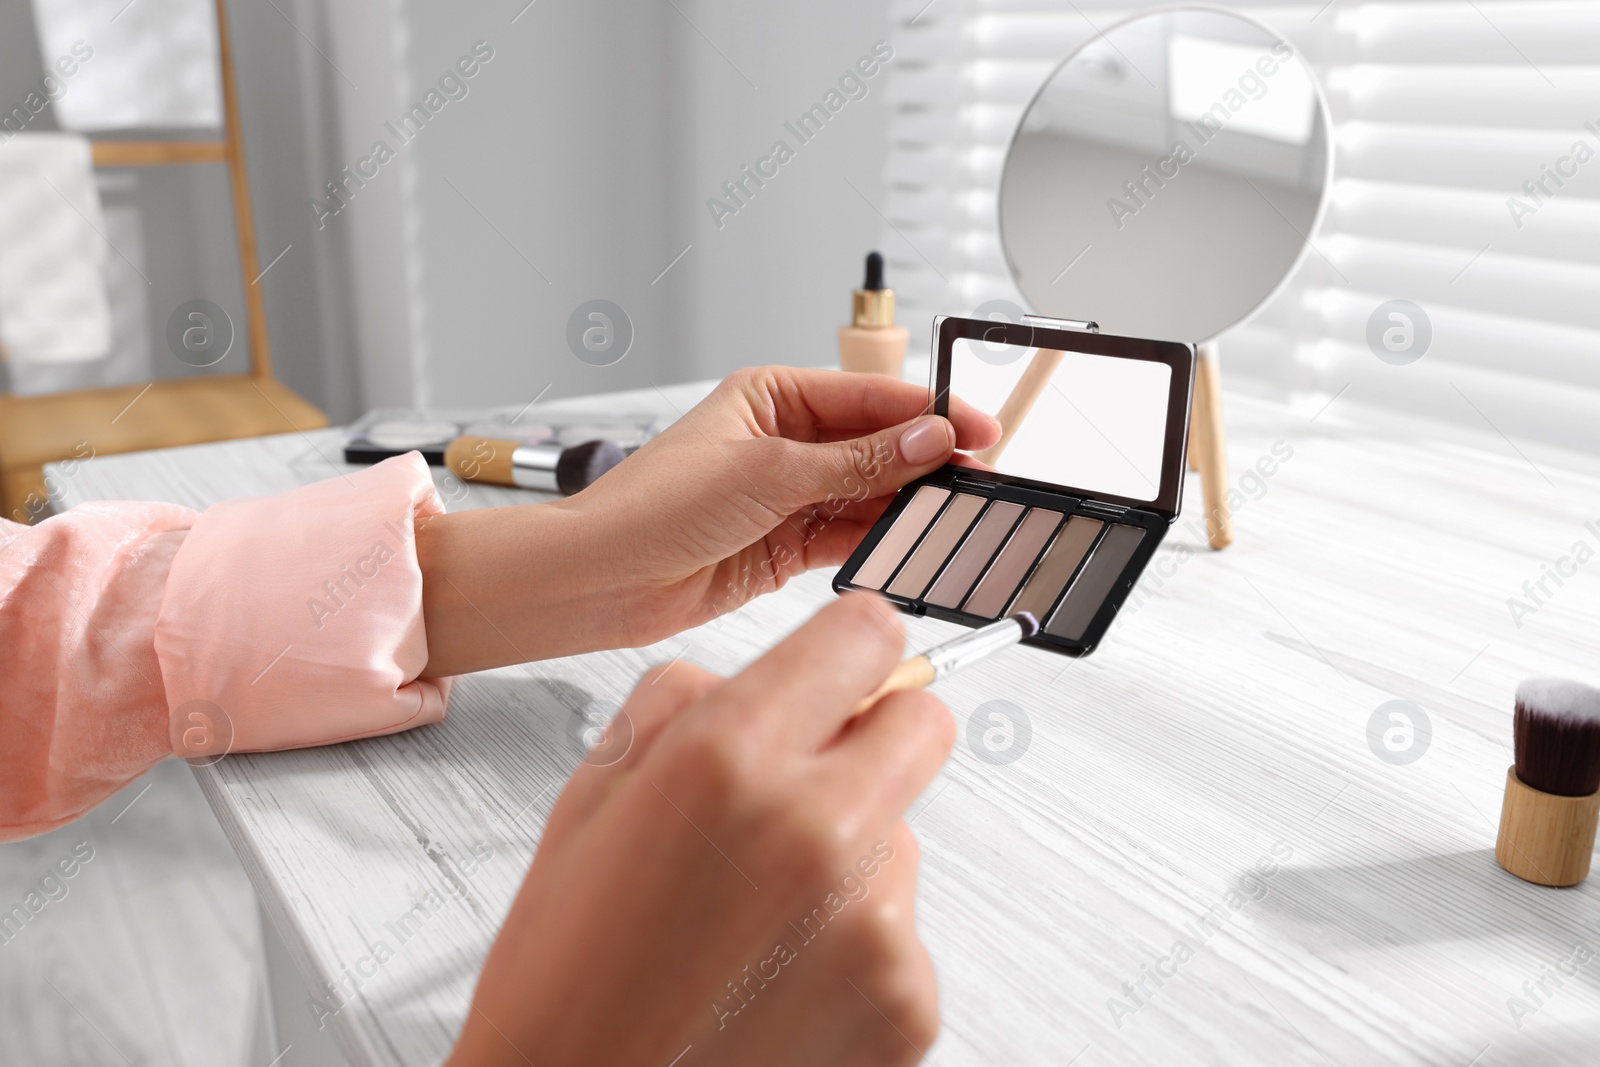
[1494,678,1600,886]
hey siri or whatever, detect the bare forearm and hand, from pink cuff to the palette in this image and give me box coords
[418,366,1000,677]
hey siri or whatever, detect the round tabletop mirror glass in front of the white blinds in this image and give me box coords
[1000,8,1331,342]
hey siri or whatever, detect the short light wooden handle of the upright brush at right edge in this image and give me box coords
[1494,766,1600,886]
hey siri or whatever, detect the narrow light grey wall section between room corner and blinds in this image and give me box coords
[669,0,894,382]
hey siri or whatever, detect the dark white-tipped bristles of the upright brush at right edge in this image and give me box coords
[1515,678,1600,797]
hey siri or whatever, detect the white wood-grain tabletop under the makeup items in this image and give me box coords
[46,386,1600,1067]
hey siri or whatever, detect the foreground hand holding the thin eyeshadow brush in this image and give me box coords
[451,595,955,1067]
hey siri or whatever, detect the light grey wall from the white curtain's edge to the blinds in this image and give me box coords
[390,0,886,405]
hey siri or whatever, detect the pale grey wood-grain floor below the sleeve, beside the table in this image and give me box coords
[0,760,265,1067]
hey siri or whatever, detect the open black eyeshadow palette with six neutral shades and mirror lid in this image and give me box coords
[834,317,1194,656]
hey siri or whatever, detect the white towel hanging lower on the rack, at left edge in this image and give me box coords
[0,133,110,363]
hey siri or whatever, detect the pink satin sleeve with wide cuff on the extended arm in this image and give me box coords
[0,453,451,840]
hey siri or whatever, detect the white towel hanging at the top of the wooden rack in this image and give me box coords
[34,0,222,131]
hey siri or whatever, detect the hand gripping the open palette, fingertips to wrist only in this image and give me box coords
[573,366,1000,645]
